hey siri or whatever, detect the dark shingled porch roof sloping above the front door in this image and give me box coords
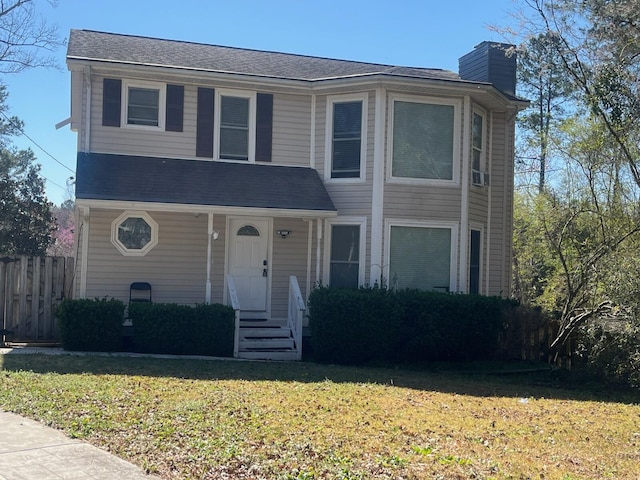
[76,153,337,212]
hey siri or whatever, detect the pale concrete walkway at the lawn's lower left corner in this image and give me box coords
[0,411,159,480]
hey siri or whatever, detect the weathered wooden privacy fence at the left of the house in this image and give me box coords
[0,255,74,343]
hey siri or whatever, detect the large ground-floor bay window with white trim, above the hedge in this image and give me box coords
[388,223,457,292]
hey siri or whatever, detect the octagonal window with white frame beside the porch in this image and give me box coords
[111,212,158,255]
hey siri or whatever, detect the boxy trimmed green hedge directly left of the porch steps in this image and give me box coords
[129,303,235,357]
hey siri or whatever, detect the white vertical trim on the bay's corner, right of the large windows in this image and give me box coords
[458,96,471,293]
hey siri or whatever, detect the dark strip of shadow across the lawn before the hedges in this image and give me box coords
[0,353,640,403]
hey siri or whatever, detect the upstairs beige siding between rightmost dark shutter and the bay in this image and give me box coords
[272,94,311,167]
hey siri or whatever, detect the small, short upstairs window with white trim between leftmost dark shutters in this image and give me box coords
[122,81,166,129]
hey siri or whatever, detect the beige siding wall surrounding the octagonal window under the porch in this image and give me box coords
[86,209,219,304]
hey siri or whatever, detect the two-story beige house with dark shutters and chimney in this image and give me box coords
[67,30,526,358]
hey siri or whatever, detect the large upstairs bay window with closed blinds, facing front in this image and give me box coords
[390,96,461,183]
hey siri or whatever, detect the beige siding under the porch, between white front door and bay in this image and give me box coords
[271,218,316,319]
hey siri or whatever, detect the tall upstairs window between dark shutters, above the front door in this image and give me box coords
[214,90,256,162]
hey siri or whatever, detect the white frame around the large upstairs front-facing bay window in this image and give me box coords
[386,94,462,186]
